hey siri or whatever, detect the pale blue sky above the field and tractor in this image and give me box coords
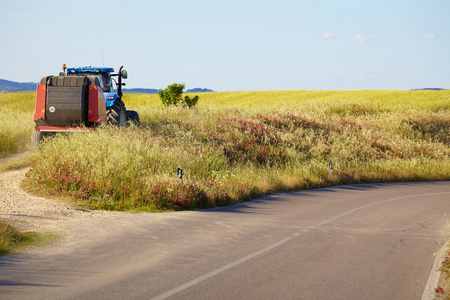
[0,0,450,91]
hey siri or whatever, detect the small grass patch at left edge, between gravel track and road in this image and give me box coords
[0,222,58,256]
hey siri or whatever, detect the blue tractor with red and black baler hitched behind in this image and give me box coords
[31,65,139,145]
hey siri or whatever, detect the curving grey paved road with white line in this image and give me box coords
[0,182,450,299]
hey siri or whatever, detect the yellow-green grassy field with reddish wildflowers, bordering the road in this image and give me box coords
[0,90,450,211]
